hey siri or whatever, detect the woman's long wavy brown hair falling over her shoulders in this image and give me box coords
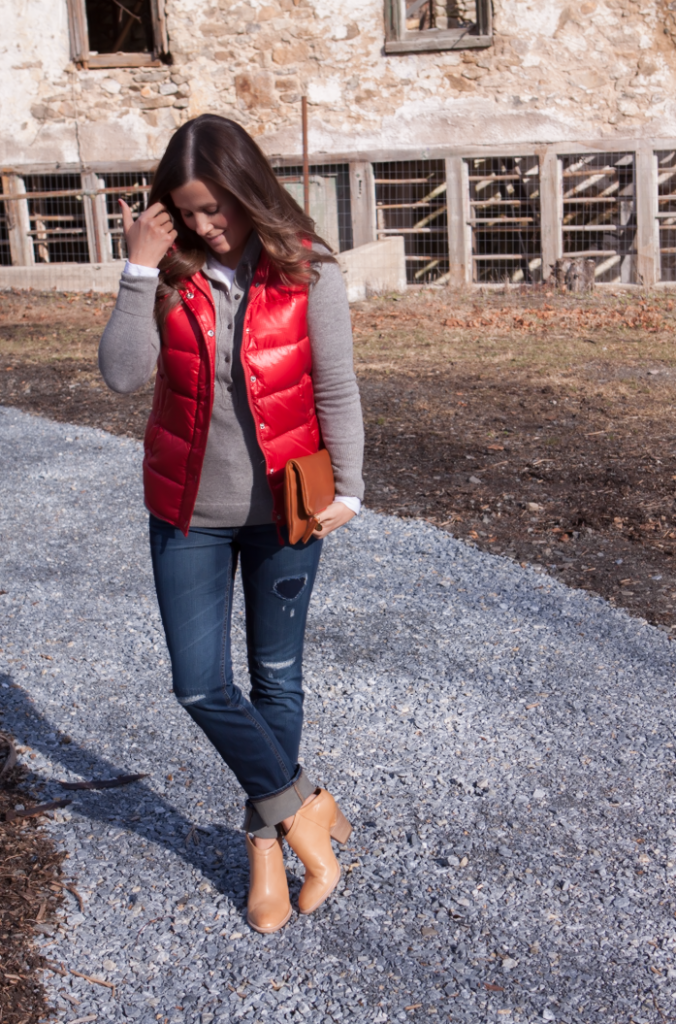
[149,114,335,322]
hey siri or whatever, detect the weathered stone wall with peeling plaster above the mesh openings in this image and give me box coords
[0,0,676,165]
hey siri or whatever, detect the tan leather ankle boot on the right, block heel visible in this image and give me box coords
[285,790,352,913]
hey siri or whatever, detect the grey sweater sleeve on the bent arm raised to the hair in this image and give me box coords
[98,273,160,394]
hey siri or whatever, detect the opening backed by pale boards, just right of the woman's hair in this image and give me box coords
[272,164,352,252]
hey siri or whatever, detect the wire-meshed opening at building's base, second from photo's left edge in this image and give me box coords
[24,174,89,263]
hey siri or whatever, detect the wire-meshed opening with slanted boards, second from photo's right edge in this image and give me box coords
[561,153,636,284]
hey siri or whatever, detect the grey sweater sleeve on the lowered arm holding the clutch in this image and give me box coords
[307,263,364,499]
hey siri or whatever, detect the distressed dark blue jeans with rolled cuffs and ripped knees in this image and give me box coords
[150,516,322,837]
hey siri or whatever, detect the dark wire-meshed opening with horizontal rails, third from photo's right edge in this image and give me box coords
[467,157,542,285]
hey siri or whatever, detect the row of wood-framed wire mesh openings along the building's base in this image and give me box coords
[0,141,676,285]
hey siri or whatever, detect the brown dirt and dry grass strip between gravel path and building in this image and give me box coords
[0,289,676,636]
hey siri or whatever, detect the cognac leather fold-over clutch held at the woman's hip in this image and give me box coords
[284,449,336,544]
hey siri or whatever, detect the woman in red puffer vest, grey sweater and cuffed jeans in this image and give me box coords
[99,115,364,932]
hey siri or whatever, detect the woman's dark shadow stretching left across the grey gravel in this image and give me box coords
[0,674,259,911]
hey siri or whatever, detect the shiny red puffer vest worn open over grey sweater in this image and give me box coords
[143,252,321,534]
